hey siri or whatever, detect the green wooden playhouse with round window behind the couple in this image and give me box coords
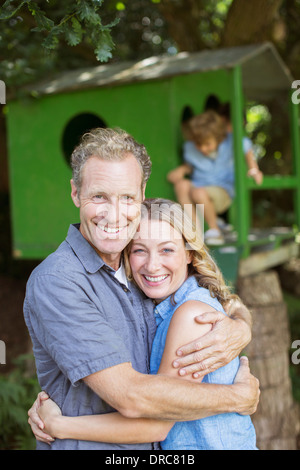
[7,43,300,281]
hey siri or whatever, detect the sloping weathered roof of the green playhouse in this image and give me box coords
[30,43,293,99]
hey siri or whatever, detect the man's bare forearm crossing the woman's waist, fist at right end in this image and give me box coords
[84,358,259,421]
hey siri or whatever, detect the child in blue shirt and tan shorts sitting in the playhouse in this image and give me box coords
[168,110,263,245]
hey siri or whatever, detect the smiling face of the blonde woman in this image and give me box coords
[129,219,191,302]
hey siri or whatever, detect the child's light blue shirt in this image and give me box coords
[183,133,252,198]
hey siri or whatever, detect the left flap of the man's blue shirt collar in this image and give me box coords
[66,224,106,274]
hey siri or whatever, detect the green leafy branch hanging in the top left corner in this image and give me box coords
[0,0,118,62]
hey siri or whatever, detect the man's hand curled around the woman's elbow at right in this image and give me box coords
[233,356,260,415]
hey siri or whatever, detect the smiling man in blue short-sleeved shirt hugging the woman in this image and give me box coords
[24,129,259,450]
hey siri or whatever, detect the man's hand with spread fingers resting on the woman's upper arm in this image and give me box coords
[173,307,251,378]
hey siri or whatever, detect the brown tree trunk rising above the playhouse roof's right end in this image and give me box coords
[222,0,283,47]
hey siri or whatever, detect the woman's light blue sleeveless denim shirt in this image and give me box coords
[150,276,256,450]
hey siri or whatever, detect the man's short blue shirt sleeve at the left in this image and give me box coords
[27,275,130,385]
